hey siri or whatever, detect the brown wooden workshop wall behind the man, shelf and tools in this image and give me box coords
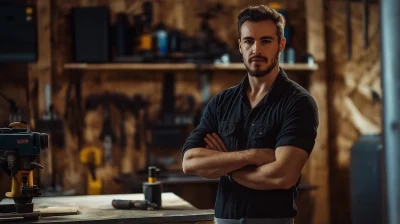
[0,0,382,223]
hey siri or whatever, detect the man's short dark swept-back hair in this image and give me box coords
[238,5,286,43]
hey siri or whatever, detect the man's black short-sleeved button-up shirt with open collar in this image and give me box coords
[182,68,319,219]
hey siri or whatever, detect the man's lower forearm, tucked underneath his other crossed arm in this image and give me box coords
[232,162,287,190]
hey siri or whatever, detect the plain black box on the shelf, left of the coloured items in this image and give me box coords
[72,7,111,63]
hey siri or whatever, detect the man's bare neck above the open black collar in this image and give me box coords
[247,64,279,97]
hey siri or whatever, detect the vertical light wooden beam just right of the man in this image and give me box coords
[305,0,330,224]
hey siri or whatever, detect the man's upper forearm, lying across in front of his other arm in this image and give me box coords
[183,148,252,178]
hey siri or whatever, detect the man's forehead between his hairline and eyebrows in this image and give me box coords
[240,20,277,38]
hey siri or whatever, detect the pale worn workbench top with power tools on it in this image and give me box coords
[0,193,214,224]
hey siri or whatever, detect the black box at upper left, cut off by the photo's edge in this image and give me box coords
[0,5,38,62]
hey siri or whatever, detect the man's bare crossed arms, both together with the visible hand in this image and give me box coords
[183,135,308,190]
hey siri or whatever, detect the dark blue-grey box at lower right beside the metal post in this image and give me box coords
[350,135,385,224]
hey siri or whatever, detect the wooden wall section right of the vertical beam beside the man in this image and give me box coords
[326,1,382,223]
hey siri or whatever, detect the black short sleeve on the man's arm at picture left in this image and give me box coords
[181,97,218,160]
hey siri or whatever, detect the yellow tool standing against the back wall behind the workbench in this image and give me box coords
[80,147,103,195]
